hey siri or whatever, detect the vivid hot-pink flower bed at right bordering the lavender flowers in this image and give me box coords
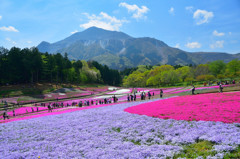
[125,92,240,123]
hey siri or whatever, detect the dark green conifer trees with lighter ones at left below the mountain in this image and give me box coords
[0,47,121,85]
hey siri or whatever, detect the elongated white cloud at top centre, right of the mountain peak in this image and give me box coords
[119,2,149,19]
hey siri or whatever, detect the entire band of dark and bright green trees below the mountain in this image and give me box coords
[0,47,240,87]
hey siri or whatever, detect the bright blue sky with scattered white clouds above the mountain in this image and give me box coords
[0,0,240,53]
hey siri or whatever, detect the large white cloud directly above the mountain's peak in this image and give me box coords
[80,12,128,31]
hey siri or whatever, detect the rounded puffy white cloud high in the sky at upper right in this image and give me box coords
[193,9,214,25]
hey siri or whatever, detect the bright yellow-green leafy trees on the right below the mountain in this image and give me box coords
[123,59,240,87]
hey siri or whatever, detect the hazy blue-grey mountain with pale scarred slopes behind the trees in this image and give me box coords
[37,27,240,69]
